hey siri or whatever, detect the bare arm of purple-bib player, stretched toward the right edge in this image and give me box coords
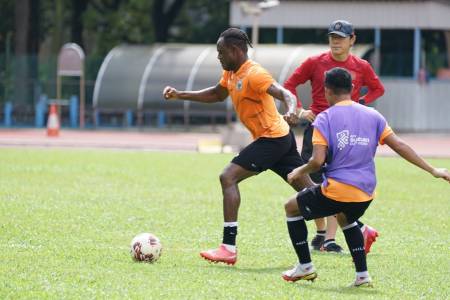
[384,133,450,183]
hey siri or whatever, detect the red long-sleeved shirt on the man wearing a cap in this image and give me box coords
[284,51,384,115]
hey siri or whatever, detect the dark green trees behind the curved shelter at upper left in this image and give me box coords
[0,0,229,104]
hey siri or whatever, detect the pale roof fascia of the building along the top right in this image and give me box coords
[230,0,450,30]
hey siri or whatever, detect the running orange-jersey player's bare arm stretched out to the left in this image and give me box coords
[163,84,228,103]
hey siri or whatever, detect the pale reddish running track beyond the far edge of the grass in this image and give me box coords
[0,129,450,158]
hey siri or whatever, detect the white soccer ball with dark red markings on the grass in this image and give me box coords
[130,233,162,263]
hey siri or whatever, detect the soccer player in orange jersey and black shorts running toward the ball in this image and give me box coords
[163,28,313,264]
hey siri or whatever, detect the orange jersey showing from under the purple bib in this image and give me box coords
[312,101,393,202]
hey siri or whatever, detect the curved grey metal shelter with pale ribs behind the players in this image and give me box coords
[93,44,369,122]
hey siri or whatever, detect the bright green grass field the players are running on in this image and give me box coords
[0,149,450,299]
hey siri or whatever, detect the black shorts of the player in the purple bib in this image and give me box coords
[297,185,372,224]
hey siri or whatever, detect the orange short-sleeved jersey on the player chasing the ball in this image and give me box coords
[220,60,289,139]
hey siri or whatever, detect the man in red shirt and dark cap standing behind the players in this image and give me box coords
[284,20,384,253]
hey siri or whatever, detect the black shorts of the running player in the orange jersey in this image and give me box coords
[231,130,303,180]
